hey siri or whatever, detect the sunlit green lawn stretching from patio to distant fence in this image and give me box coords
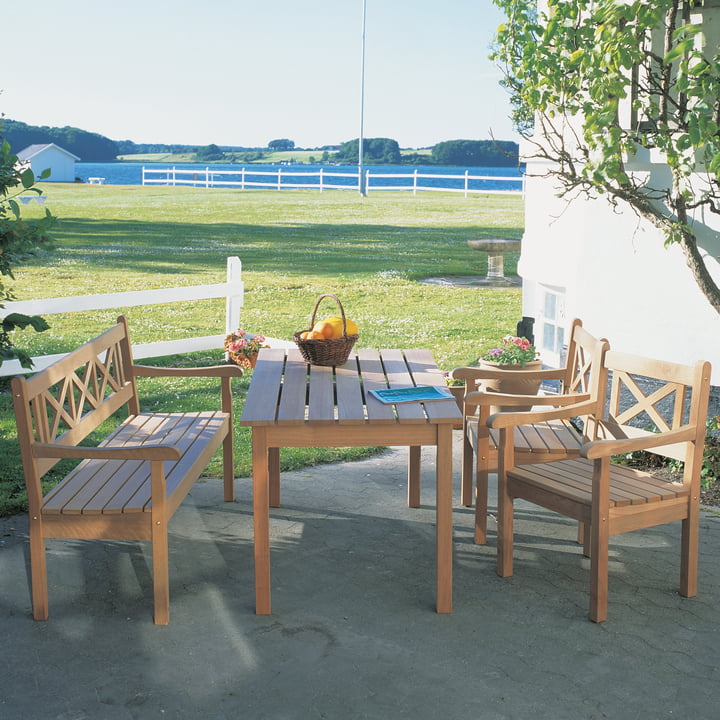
[0,184,523,514]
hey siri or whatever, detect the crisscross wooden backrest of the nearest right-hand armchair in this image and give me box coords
[599,351,710,470]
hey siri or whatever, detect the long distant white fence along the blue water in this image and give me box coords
[142,167,523,197]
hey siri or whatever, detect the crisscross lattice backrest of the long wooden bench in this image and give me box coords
[11,317,139,480]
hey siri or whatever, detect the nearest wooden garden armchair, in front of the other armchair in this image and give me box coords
[490,352,710,622]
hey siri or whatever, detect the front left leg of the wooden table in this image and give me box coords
[252,427,270,615]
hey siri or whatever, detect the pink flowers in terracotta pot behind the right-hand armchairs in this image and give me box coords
[478,335,542,412]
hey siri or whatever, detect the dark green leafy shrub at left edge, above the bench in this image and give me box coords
[0,121,55,368]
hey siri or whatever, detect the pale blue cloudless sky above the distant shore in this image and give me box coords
[0,0,516,147]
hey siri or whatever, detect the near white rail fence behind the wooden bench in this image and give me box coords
[0,257,292,376]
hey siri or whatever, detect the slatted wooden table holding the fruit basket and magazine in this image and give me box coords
[240,348,460,615]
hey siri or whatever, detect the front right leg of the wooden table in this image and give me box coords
[435,423,453,613]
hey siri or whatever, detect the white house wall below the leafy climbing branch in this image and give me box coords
[518,155,720,385]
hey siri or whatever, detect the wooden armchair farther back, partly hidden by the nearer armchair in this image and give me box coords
[451,319,609,544]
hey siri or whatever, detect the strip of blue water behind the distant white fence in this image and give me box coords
[75,162,521,192]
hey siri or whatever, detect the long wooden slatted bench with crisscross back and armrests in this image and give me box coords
[12,316,242,625]
